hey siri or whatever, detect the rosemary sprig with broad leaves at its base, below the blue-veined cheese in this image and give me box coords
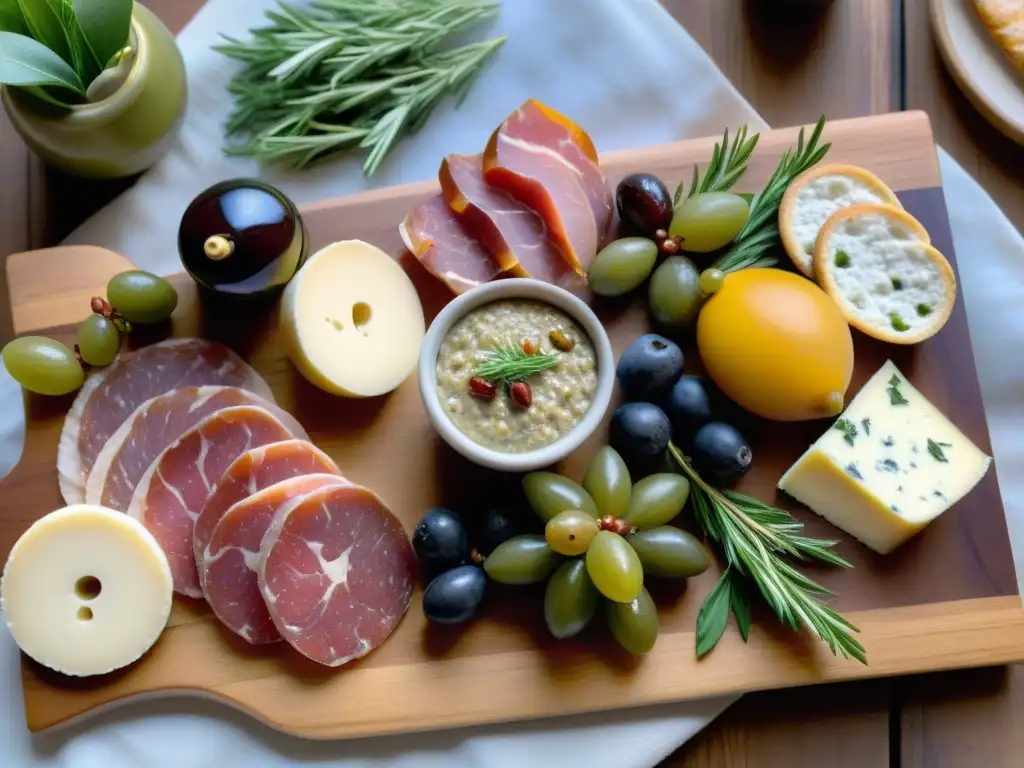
[669,442,867,664]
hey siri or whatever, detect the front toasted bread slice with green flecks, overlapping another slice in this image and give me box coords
[814,205,956,344]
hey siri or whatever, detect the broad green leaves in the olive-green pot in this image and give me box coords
[0,0,132,105]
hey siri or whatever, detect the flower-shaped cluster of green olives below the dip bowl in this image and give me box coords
[483,445,709,653]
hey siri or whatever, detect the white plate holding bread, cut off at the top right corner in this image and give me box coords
[931,0,1024,144]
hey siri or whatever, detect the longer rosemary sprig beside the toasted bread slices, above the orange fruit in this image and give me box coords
[715,115,831,272]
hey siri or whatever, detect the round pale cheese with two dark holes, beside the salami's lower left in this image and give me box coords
[0,504,173,677]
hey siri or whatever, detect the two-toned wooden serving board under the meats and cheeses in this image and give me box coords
[0,113,1024,738]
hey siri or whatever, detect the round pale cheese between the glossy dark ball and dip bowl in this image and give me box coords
[281,240,426,397]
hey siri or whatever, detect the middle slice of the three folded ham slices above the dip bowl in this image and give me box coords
[438,155,581,288]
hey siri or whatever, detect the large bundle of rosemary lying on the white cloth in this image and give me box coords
[216,0,504,176]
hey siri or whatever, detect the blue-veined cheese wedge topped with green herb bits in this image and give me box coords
[778,360,991,554]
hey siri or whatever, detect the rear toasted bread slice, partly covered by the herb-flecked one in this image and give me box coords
[778,164,903,278]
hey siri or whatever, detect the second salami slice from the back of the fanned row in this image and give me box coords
[85,386,307,512]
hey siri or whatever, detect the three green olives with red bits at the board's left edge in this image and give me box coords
[2,269,178,395]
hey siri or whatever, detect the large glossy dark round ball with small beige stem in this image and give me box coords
[178,179,309,297]
